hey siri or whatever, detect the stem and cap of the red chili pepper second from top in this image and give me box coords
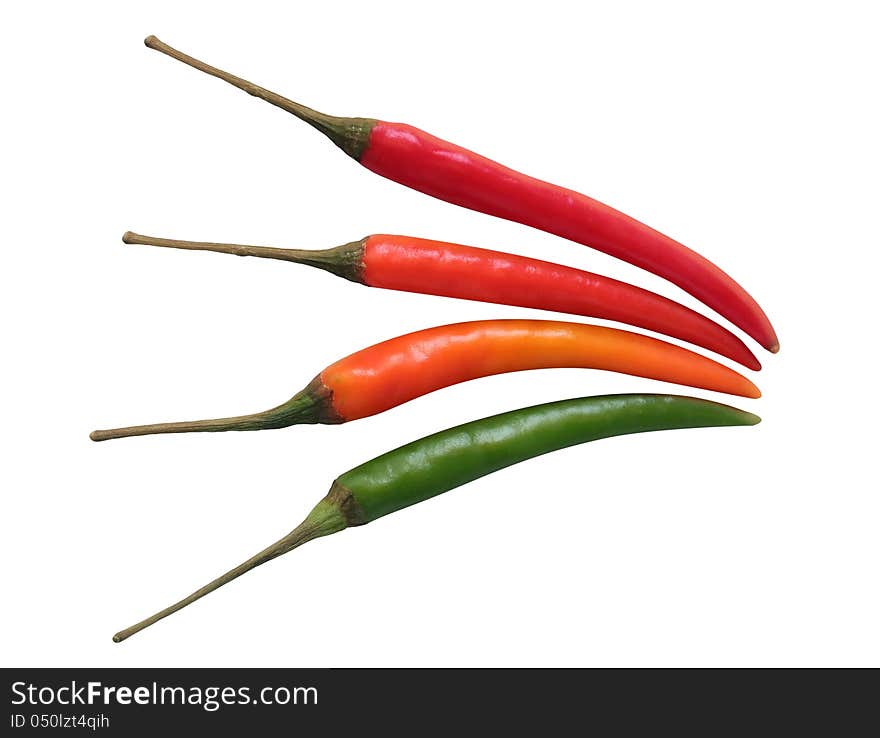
[122,231,367,284]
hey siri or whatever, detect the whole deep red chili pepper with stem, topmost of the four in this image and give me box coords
[144,36,779,353]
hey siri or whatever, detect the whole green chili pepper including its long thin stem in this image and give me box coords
[113,395,761,643]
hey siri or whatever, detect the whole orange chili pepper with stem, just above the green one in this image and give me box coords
[91,320,761,441]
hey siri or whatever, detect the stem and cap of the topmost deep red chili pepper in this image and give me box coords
[144,36,375,159]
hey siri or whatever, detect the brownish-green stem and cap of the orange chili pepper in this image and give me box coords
[89,377,342,441]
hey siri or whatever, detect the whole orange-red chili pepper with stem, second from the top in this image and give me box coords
[122,231,761,370]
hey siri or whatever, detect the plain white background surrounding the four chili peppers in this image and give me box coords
[0,0,880,666]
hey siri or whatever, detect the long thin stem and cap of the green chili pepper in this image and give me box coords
[113,493,349,643]
